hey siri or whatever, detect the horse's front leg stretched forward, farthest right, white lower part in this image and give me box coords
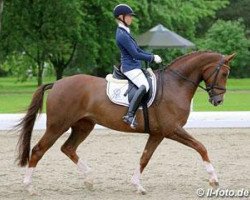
[168,127,219,187]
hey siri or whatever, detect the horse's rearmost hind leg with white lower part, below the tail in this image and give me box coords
[23,127,64,194]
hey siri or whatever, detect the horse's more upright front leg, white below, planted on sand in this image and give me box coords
[131,135,163,194]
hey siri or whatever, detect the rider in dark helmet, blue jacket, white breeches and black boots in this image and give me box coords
[113,4,162,128]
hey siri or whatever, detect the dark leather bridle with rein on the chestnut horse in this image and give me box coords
[169,57,230,98]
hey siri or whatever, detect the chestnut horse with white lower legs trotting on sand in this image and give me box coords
[17,51,234,194]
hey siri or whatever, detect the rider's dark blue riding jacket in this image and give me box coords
[116,27,154,72]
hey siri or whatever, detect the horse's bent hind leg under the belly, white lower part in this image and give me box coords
[61,119,95,189]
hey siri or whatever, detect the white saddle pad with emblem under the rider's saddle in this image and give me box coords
[106,68,156,107]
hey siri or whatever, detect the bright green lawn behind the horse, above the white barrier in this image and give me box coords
[0,77,250,113]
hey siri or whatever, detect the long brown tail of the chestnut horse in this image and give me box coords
[16,83,54,167]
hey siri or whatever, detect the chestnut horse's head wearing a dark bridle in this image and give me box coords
[202,54,235,106]
